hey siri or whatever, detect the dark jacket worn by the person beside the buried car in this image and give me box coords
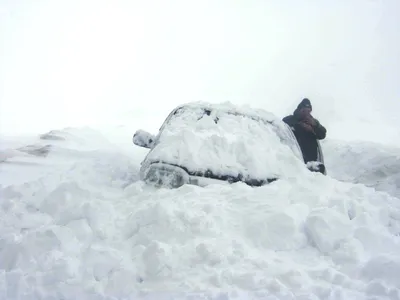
[283,111,326,163]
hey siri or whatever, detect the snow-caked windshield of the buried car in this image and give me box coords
[148,107,304,179]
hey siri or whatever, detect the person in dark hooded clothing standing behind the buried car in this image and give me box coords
[282,98,327,173]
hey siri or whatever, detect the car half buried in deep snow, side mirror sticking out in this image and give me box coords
[133,102,324,188]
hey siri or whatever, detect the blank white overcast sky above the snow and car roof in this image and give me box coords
[0,0,400,142]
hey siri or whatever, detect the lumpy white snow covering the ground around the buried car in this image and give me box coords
[0,120,400,300]
